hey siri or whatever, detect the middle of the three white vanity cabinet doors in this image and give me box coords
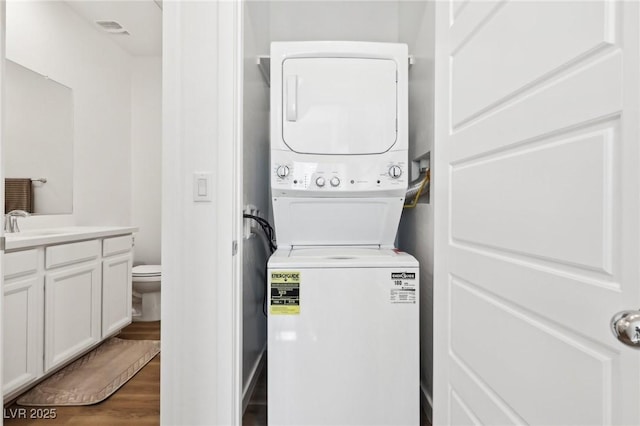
[45,262,101,372]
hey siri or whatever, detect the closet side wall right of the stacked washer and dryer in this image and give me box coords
[399,2,435,420]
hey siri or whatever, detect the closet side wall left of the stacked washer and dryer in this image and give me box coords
[242,2,270,408]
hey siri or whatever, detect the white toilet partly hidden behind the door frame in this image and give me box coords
[131,265,162,321]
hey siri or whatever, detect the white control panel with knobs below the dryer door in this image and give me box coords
[271,151,408,197]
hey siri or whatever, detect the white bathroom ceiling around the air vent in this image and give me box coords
[67,0,162,56]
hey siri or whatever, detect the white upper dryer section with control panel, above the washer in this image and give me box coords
[271,42,409,247]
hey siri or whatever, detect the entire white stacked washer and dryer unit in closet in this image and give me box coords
[267,42,420,426]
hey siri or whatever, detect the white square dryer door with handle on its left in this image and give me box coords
[282,58,397,154]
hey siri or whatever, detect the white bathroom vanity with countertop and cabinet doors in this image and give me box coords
[2,227,137,401]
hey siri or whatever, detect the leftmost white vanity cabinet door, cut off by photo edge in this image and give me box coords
[2,276,43,395]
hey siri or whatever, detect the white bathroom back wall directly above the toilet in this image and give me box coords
[131,57,162,264]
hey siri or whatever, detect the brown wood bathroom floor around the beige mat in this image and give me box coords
[4,321,160,426]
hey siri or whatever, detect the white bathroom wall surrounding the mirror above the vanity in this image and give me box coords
[5,1,132,229]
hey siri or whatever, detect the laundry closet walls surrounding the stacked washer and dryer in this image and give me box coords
[242,1,435,420]
